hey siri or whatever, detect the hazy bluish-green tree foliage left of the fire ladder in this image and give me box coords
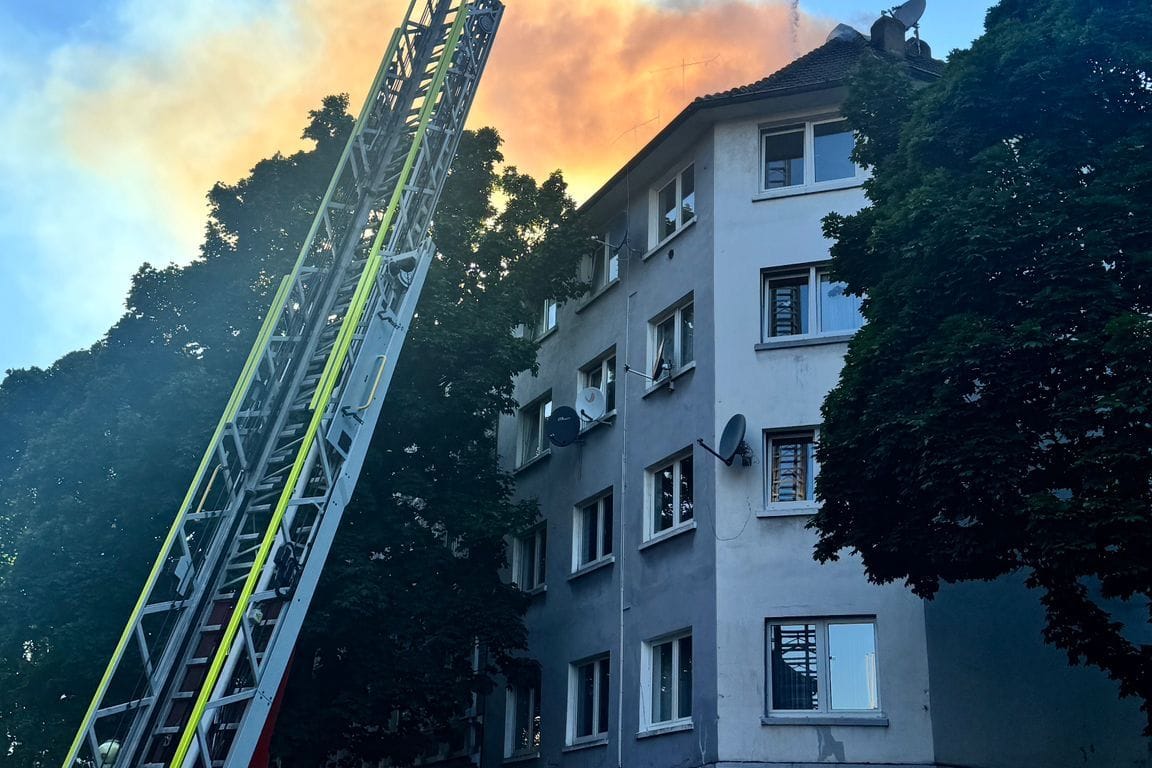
[0,97,350,766]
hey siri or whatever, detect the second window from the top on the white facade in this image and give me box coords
[761,267,864,341]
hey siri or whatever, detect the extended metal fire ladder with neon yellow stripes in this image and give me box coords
[63,0,503,768]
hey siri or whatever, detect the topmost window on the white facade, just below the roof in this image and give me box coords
[760,120,858,191]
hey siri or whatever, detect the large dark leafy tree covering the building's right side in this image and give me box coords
[813,0,1152,732]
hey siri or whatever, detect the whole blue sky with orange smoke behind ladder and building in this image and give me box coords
[0,0,991,372]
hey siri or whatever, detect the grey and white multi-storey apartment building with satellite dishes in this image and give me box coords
[482,16,1150,768]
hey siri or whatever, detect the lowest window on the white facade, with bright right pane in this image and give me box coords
[767,618,880,713]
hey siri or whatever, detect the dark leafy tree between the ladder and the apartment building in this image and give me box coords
[273,130,589,767]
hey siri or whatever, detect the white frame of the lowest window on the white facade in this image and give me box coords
[764,616,884,720]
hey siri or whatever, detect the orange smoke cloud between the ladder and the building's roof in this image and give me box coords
[473,0,832,197]
